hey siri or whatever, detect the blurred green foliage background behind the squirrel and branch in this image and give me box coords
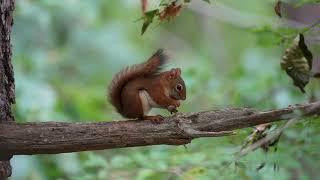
[11,0,320,180]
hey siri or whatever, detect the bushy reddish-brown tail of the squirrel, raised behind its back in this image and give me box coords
[108,49,168,114]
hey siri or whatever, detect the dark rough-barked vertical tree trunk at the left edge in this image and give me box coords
[0,0,15,179]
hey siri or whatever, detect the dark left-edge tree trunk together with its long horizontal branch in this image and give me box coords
[0,0,320,180]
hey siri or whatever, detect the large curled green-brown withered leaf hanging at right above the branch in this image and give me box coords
[280,34,312,93]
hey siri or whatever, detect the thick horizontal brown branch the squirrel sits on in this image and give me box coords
[0,101,320,155]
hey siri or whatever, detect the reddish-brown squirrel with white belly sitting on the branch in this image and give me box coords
[109,49,186,122]
